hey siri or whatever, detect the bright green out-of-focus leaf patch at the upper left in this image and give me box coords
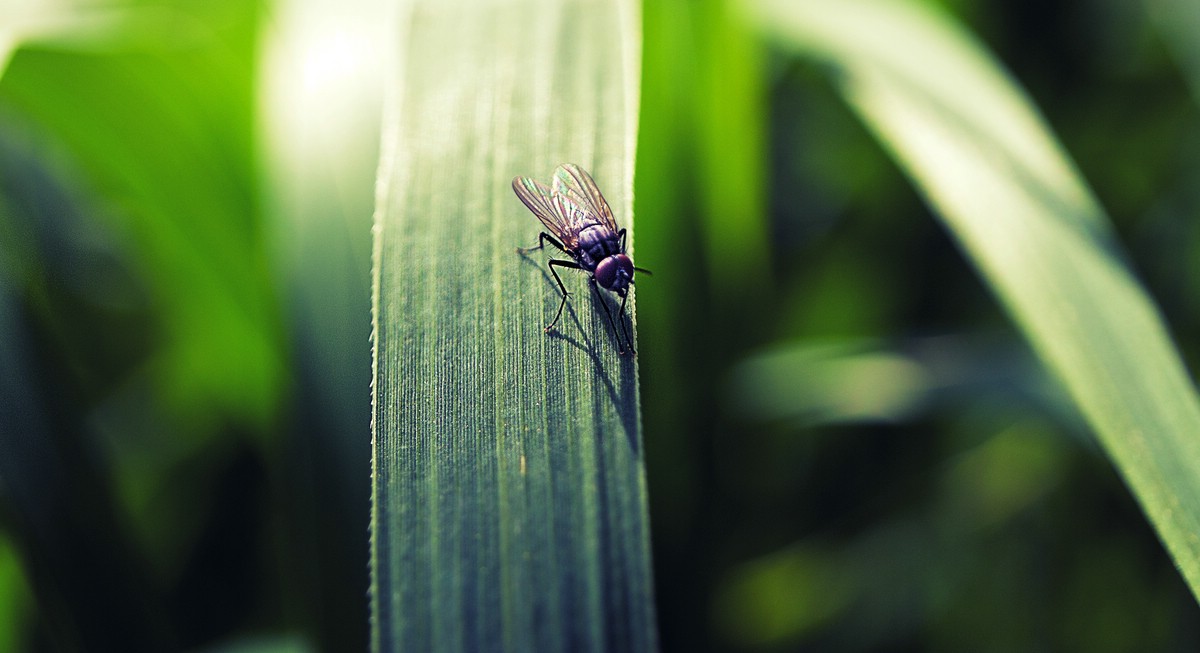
[0,4,280,441]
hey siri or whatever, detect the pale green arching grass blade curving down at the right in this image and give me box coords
[752,0,1200,595]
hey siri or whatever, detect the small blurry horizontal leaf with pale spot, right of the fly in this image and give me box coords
[728,336,1085,432]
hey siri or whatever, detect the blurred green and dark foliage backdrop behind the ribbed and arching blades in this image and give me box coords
[0,0,1200,652]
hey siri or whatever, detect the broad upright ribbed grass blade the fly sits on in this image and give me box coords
[371,0,656,651]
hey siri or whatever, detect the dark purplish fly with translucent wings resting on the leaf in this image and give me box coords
[512,163,650,354]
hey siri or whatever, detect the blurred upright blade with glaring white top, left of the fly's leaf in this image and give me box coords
[260,0,390,651]
